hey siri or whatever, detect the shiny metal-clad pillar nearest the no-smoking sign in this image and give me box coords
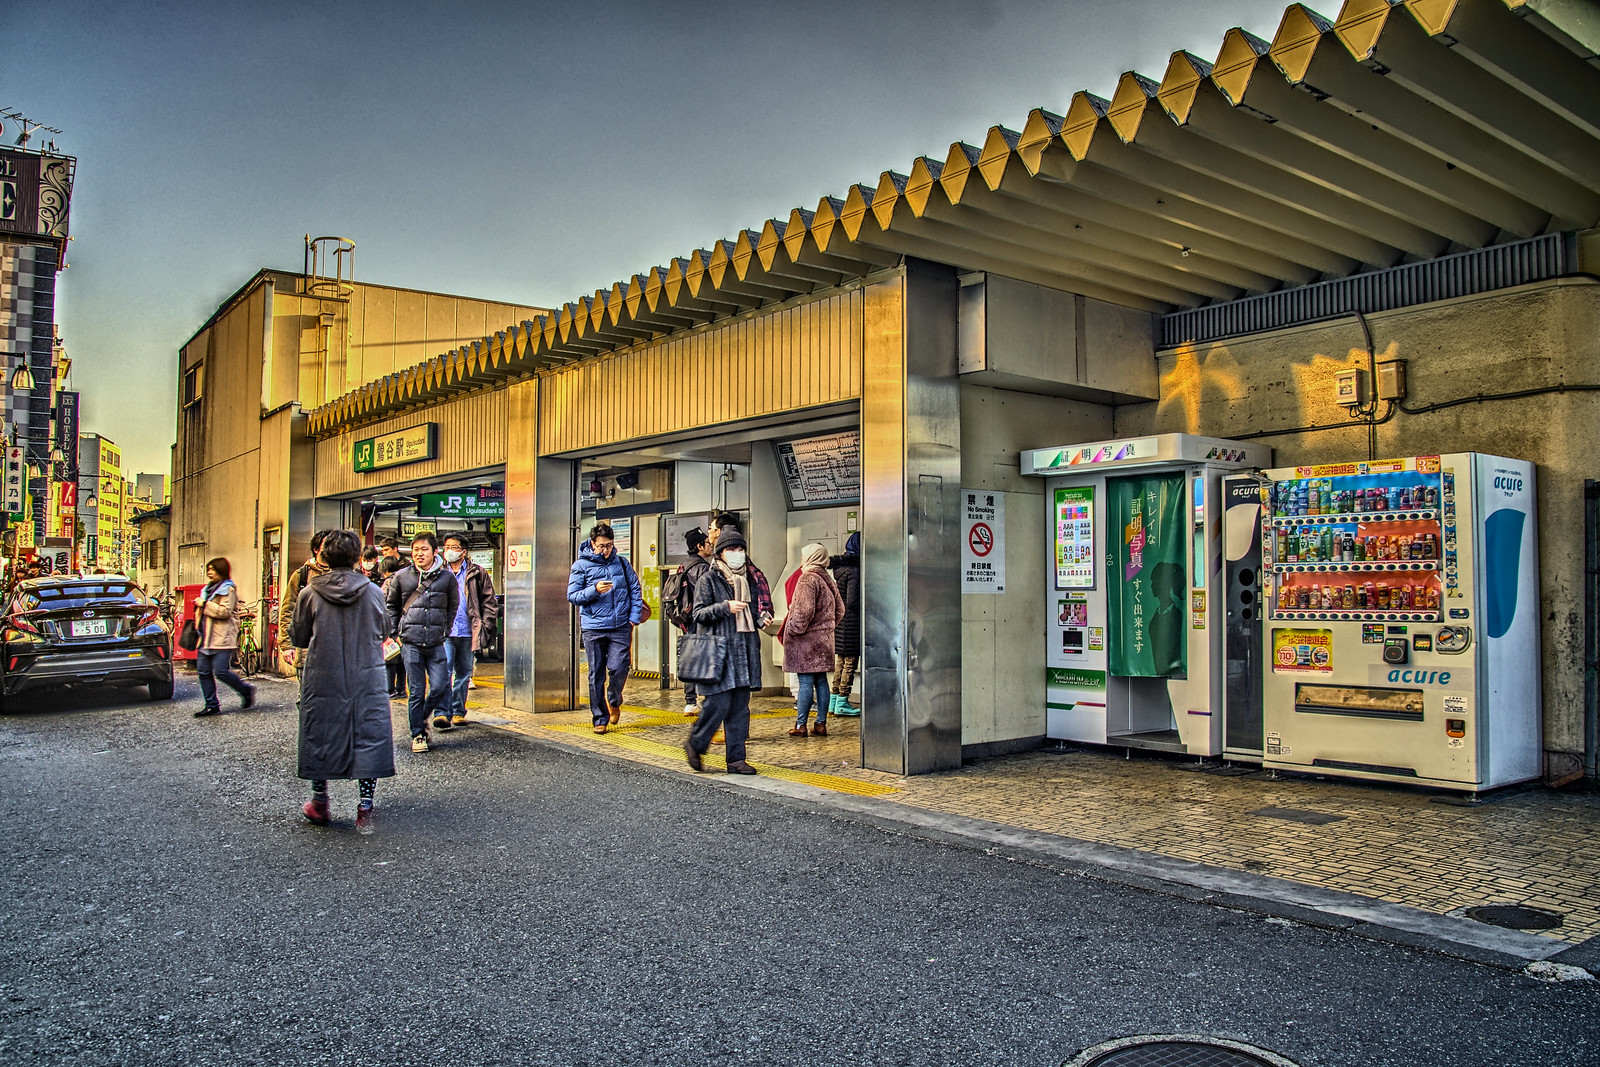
[861,259,962,774]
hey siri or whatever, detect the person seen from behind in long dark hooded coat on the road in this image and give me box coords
[293,530,395,833]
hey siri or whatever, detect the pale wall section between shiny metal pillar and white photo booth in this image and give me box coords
[962,384,1112,753]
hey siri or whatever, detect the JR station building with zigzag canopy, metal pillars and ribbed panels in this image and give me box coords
[184,0,1600,781]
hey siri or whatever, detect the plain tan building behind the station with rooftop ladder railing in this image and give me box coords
[166,254,538,645]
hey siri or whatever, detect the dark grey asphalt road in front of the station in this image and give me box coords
[0,681,1600,1067]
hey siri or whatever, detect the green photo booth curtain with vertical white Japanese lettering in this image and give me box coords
[1106,474,1189,678]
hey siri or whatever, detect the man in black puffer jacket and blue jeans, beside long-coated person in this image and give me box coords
[387,533,461,752]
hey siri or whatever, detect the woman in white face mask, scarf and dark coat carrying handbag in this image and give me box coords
[683,530,762,774]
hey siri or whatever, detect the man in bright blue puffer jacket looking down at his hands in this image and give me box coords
[566,523,645,734]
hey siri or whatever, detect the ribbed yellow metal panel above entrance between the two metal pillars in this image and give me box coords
[537,286,866,456]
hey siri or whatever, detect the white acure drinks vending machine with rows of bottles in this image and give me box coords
[1261,453,1541,792]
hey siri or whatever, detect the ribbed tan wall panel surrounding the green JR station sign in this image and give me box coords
[317,389,509,496]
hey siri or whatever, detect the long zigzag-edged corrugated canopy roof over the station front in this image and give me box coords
[310,0,1600,435]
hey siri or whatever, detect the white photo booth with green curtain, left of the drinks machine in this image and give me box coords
[1022,434,1272,755]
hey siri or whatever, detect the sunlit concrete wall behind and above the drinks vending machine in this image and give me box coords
[1115,278,1600,774]
